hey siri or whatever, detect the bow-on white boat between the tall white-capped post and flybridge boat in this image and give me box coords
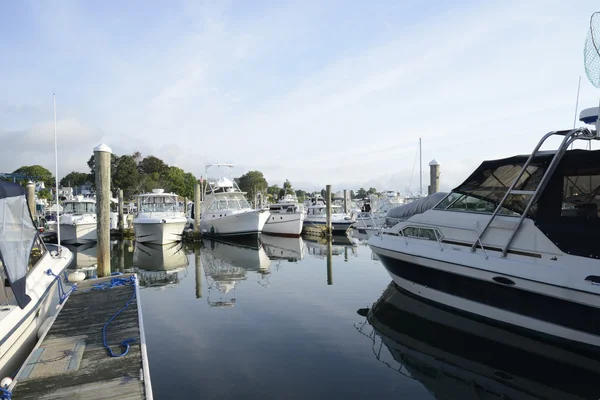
[133,189,187,244]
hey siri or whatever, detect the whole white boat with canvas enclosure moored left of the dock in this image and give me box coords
[0,182,72,378]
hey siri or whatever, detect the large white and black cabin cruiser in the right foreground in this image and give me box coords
[368,121,600,348]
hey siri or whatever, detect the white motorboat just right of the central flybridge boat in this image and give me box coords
[263,194,305,237]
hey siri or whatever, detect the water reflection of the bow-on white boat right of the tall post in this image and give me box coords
[133,242,188,286]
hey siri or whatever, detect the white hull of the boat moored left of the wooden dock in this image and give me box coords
[0,247,73,377]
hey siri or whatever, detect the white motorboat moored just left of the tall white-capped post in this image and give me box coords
[60,196,98,244]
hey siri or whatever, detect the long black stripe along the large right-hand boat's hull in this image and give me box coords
[377,254,600,335]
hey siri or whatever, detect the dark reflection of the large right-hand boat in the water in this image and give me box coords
[357,283,600,400]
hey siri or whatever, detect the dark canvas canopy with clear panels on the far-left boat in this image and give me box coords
[0,181,38,308]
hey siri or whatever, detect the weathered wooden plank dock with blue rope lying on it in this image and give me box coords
[11,274,152,400]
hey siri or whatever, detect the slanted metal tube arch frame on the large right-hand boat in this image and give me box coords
[471,128,600,257]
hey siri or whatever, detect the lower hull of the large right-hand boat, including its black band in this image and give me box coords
[371,246,600,351]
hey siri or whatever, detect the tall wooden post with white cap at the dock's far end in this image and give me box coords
[94,143,112,277]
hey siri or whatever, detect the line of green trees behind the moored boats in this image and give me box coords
[13,161,390,201]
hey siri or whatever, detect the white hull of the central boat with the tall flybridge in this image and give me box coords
[200,210,271,236]
